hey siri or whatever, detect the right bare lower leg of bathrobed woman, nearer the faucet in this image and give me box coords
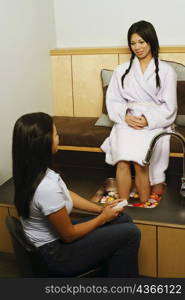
[134,163,150,202]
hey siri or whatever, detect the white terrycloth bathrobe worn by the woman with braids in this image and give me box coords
[101,57,177,185]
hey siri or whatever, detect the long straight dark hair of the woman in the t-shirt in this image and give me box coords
[12,112,53,218]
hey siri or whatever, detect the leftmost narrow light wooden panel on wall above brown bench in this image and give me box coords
[51,55,73,116]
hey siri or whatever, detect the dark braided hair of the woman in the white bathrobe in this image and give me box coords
[121,21,160,87]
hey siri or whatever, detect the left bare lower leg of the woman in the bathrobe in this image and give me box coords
[116,161,132,199]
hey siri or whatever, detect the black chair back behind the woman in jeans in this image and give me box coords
[5,216,48,277]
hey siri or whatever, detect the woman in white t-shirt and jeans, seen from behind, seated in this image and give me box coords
[12,112,140,277]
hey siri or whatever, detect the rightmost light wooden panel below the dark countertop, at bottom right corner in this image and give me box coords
[158,227,185,278]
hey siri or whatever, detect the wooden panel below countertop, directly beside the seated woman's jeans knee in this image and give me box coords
[136,224,157,277]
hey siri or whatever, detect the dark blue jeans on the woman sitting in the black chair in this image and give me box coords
[39,213,140,278]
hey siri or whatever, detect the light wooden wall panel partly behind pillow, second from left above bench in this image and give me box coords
[72,54,118,117]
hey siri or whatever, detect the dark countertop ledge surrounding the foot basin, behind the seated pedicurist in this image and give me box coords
[0,168,185,225]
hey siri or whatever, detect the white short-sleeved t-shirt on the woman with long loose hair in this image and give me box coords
[21,169,73,247]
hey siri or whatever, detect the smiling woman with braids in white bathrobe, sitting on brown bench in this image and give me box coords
[101,21,177,202]
